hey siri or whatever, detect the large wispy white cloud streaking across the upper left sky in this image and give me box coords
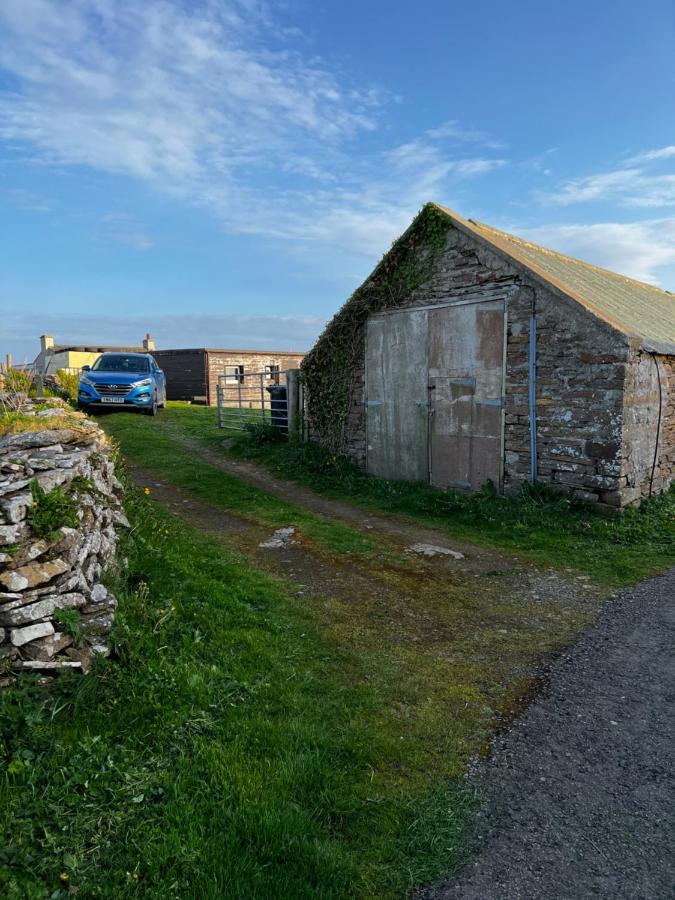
[0,0,505,255]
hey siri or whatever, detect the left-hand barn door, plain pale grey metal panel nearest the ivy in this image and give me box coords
[366,310,429,482]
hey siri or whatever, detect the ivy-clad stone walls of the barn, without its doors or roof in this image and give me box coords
[303,204,675,507]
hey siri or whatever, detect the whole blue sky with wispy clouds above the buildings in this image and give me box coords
[0,0,675,362]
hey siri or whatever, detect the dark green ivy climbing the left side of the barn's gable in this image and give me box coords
[302,203,452,453]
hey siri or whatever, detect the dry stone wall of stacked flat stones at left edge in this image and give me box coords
[0,398,128,672]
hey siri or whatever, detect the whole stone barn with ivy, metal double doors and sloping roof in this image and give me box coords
[302,204,675,509]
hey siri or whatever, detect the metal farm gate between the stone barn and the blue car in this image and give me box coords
[216,369,298,433]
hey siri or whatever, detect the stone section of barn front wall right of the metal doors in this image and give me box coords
[504,279,629,506]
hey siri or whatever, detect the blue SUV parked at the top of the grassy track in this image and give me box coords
[77,353,166,416]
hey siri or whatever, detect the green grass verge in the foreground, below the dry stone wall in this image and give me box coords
[0,493,476,900]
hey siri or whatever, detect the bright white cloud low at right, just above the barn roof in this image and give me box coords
[518,218,675,289]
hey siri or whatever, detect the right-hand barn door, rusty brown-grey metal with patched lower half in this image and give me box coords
[428,303,504,490]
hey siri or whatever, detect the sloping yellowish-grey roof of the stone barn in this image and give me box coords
[434,204,675,354]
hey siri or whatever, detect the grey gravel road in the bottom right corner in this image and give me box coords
[416,569,675,900]
